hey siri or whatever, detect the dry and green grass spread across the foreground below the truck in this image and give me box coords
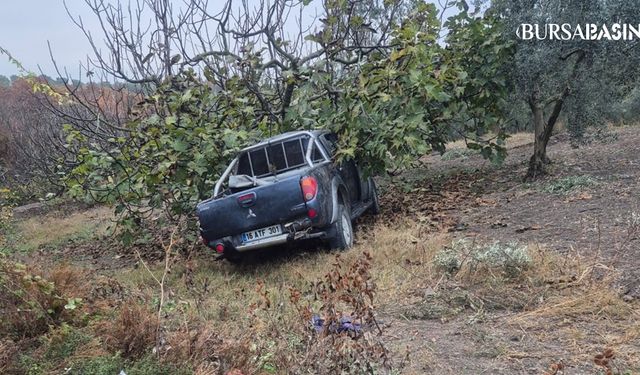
[0,207,640,374]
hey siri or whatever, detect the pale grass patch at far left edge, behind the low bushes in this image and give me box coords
[3,207,112,254]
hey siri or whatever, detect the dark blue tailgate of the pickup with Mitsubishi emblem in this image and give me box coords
[197,175,306,240]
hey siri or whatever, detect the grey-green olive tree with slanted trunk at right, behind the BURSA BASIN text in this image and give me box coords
[489,0,640,178]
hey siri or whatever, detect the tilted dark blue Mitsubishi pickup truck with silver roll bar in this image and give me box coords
[197,131,380,261]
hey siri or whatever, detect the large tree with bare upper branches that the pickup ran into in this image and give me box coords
[58,0,510,239]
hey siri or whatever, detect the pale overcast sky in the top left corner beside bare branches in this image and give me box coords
[0,0,452,78]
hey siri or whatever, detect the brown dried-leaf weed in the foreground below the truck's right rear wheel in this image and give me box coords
[291,251,391,374]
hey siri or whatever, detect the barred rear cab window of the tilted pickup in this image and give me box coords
[236,137,324,177]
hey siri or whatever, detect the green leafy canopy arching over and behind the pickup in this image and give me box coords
[57,1,512,239]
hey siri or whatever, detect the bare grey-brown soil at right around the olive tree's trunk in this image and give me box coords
[416,127,640,298]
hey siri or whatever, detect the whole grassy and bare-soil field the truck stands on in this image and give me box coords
[0,127,640,375]
